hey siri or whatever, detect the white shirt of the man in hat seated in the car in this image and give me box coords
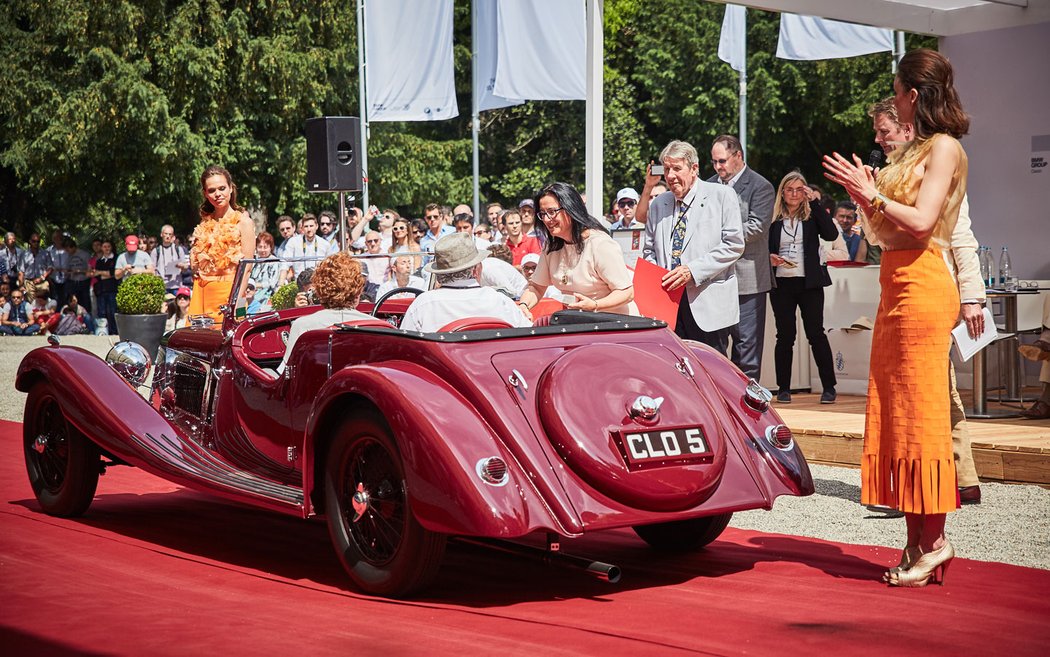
[401,280,531,333]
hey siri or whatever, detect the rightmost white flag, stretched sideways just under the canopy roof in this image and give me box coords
[777,14,894,60]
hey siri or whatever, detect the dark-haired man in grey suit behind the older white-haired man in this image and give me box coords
[708,134,776,381]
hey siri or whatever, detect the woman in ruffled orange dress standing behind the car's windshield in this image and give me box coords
[189,165,255,325]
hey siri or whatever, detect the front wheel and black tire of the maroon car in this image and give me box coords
[22,381,102,517]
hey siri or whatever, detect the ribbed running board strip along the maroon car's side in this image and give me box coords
[131,433,303,515]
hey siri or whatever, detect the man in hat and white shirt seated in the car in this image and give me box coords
[401,233,530,332]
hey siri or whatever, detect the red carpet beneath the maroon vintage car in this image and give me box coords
[0,422,1050,657]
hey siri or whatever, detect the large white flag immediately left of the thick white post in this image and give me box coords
[492,0,587,101]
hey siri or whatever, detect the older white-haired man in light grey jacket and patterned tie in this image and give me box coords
[642,141,743,354]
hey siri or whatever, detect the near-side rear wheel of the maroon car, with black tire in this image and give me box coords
[324,416,445,597]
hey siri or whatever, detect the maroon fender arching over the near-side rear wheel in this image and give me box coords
[303,361,572,537]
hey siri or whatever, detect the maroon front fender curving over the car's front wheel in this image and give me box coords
[15,346,176,465]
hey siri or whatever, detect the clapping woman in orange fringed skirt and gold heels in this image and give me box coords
[824,49,969,587]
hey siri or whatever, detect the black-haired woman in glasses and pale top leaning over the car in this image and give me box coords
[519,183,638,318]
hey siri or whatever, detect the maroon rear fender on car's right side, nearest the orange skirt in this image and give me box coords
[688,342,814,495]
